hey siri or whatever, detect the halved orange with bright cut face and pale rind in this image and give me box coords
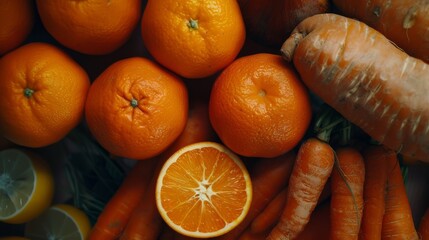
[156,142,252,238]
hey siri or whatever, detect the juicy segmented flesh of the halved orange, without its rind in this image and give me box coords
[161,148,247,232]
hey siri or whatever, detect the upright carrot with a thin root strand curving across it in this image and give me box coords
[330,147,365,240]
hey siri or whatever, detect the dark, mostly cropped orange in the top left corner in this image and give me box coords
[0,0,34,55]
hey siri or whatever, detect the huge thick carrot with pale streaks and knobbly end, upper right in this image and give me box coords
[281,14,429,162]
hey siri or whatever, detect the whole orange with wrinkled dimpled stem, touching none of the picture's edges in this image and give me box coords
[85,57,188,160]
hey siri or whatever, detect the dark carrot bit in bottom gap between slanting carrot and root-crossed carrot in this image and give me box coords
[296,201,331,240]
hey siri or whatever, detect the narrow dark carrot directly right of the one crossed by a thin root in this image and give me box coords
[359,146,395,240]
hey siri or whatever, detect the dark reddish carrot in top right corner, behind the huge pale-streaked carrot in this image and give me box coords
[333,0,429,62]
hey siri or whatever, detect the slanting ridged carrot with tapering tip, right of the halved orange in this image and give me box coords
[267,138,335,240]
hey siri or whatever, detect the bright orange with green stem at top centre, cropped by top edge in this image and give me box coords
[141,0,245,78]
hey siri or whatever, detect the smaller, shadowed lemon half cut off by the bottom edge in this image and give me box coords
[24,203,91,240]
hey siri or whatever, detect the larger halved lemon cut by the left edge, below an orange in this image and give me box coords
[0,148,54,224]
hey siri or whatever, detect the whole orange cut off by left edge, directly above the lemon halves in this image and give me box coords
[0,43,90,147]
